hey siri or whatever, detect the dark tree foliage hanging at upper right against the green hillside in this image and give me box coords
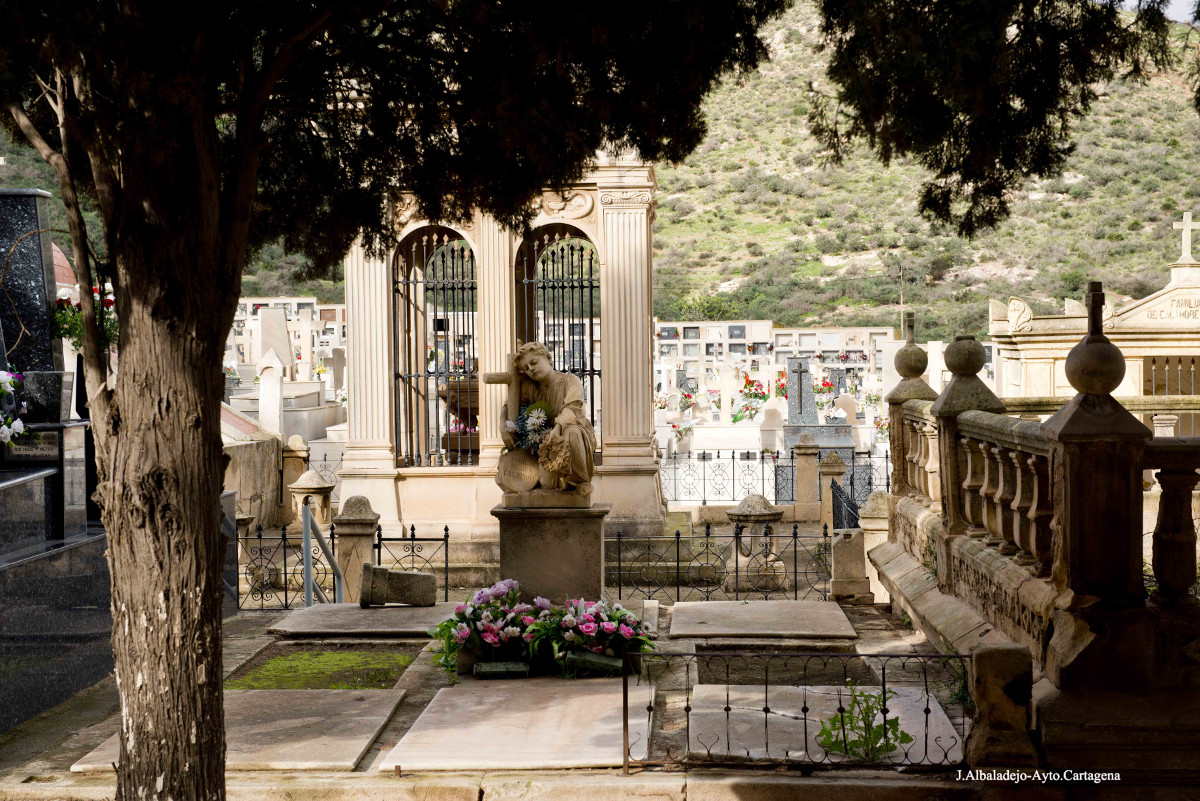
[812,0,1180,236]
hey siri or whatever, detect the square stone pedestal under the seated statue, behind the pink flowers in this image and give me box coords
[492,504,612,604]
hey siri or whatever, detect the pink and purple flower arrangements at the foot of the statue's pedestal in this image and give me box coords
[430,579,653,675]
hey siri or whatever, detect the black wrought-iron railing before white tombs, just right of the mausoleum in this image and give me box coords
[659,451,796,506]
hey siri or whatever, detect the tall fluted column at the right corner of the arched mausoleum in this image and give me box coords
[599,187,654,464]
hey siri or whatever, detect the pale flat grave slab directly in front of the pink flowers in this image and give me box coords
[379,677,654,773]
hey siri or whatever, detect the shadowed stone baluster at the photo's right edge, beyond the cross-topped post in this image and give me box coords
[1153,470,1200,601]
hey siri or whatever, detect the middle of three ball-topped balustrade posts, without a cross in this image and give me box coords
[930,337,1004,592]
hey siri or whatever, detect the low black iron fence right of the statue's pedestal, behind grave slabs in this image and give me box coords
[605,524,830,603]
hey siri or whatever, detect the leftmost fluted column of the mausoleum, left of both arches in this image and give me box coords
[343,243,395,470]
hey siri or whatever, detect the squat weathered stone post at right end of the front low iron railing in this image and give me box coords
[967,645,1038,767]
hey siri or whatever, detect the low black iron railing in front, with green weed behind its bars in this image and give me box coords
[623,652,973,770]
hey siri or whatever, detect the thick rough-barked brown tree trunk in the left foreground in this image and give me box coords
[97,270,226,801]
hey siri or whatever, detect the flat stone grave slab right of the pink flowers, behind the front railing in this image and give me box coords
[671,601,857,639]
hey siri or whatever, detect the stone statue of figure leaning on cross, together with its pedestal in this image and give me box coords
[484,342,612,603]
